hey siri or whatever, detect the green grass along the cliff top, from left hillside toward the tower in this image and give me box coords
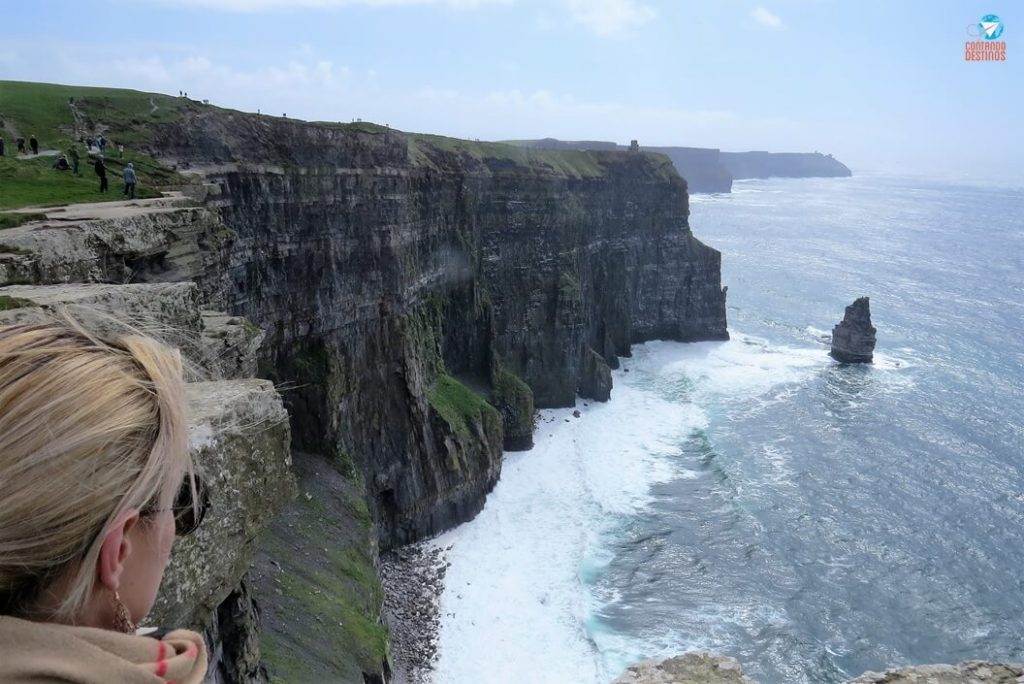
[0,81,675,210]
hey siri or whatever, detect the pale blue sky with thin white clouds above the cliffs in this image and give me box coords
[0,0,1024,180]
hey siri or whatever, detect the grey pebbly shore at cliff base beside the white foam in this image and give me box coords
[380,542,452,684]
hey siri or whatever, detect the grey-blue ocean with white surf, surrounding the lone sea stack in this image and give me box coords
[434,173,1024,684]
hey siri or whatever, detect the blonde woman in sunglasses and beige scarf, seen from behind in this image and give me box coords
[0,322,207,684]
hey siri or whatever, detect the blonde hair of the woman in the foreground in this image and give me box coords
[0,320,191,623]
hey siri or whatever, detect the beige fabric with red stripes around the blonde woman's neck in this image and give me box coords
[0,615,206,684]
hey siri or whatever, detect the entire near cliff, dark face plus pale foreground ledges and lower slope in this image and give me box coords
[0,86,727,682]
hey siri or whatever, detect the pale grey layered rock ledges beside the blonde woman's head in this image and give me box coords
[0,208,295,683]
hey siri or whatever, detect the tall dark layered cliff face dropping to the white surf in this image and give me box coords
[149,109,726,546]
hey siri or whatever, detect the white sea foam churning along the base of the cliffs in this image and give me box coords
[434,333,829,684]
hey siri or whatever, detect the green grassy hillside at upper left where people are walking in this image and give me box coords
[0,81,187,209]
